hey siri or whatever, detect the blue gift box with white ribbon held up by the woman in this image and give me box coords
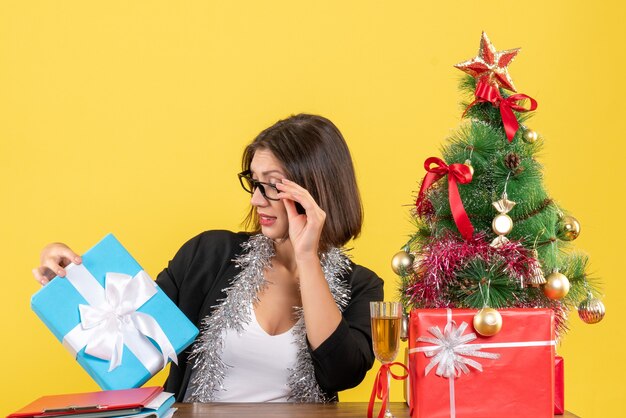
[31,234,198,390]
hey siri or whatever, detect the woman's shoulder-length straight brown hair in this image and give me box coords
[241,114,363,251]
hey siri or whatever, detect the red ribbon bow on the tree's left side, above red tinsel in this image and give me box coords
[415,157,474,240]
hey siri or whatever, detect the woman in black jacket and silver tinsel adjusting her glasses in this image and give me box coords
[33,114,383,402]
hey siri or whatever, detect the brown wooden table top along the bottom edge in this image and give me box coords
[174,402,578,418]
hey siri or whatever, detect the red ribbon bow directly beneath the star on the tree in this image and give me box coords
[463,80,537,142]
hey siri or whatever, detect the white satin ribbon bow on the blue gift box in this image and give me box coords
[63,264,178,374]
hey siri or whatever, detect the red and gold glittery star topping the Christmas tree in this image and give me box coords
[455,32,520,92]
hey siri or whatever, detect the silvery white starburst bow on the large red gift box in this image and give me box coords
[416,321,500,379]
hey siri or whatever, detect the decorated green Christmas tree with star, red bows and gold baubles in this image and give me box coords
[392,33,604,335]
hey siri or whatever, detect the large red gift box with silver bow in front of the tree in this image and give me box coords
[409,309,555,418]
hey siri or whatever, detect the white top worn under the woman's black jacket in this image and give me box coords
[210,307,297,402]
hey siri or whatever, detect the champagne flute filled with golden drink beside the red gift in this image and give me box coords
[370,302,402,418]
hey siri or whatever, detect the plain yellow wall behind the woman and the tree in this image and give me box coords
[0,0,626,418]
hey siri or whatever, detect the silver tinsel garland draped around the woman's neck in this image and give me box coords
[184,234,350,402]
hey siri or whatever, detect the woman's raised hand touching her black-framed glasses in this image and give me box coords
[276,179,326,258]
